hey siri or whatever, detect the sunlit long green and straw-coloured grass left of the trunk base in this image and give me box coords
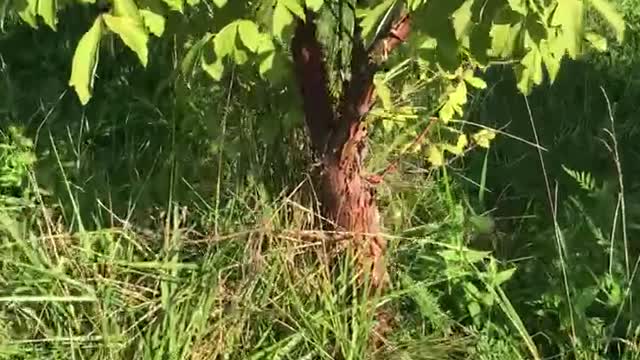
[0,153,476,359]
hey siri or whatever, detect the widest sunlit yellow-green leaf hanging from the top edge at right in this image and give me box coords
[551,0,584,59]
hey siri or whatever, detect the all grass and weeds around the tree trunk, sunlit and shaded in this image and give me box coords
[0,1,640,360]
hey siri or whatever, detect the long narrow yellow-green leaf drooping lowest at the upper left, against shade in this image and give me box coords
[69,16,102,105]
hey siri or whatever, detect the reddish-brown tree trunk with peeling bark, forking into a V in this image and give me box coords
[291,12,410,289]
